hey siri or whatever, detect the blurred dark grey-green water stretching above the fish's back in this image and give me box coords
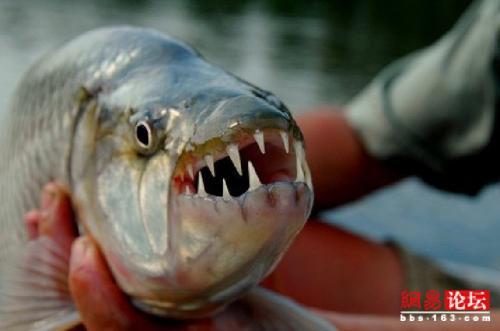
[0,0,467,110]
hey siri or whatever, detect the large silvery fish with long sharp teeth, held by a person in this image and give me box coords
[0,26,334,330]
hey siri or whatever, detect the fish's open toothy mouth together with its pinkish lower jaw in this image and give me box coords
[118,128,313,318]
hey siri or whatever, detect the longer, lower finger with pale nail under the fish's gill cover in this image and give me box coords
[69,237,160,331]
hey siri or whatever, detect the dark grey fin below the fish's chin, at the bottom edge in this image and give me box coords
[216,288,337,331]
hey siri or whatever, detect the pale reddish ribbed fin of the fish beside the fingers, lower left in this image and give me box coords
[0,236,80,331]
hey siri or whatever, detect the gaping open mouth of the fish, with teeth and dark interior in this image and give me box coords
[172,129,311,200]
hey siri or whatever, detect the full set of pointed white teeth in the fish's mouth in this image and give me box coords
[185,130,312,200]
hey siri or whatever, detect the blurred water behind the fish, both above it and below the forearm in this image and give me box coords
[0,0,500,270]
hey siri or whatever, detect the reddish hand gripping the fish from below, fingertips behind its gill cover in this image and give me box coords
[25,183,338,331]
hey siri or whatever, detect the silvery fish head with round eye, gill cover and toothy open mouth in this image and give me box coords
[72,63,313,318]
